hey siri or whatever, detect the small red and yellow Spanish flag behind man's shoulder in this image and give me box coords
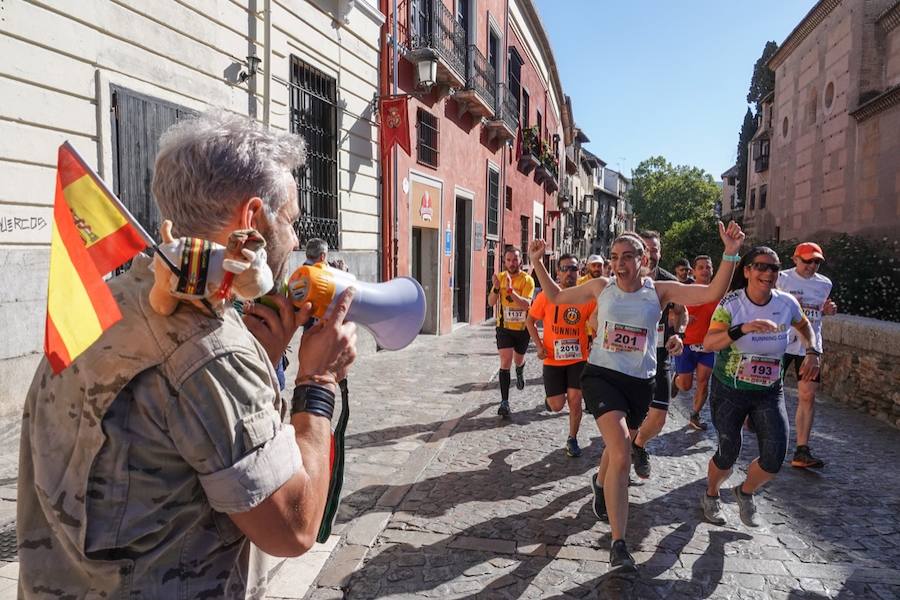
[44,142,154,373]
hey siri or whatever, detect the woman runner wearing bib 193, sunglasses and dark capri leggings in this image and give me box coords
[701,246,819,527]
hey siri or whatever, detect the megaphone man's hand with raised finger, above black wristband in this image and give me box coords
[297,287,356,390]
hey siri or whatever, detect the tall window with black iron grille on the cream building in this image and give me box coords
[290,56,340,248]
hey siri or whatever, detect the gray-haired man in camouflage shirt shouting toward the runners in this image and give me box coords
[16,112,356,598]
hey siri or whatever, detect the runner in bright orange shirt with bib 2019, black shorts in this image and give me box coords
[525,254,597,458]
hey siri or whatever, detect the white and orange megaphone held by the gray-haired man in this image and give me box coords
[288,263,425,350]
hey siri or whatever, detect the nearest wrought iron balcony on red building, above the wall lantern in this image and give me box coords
[406,0,466,88]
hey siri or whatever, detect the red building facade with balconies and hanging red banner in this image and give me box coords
[380,0,562,334]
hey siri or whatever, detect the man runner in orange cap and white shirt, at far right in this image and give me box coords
[778,242,837,469]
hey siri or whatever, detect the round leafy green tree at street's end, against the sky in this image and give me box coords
[627,156,720,233]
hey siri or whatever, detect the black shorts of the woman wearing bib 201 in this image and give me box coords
[581,363,656,429]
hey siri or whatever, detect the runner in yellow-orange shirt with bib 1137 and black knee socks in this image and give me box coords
[488,246,534,419]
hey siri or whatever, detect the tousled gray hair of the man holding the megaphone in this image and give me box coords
[152,110,306,237]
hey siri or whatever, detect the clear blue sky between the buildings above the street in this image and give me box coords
[536,0,815,181]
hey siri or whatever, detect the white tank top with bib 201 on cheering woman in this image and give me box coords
[588,277,662,379]
